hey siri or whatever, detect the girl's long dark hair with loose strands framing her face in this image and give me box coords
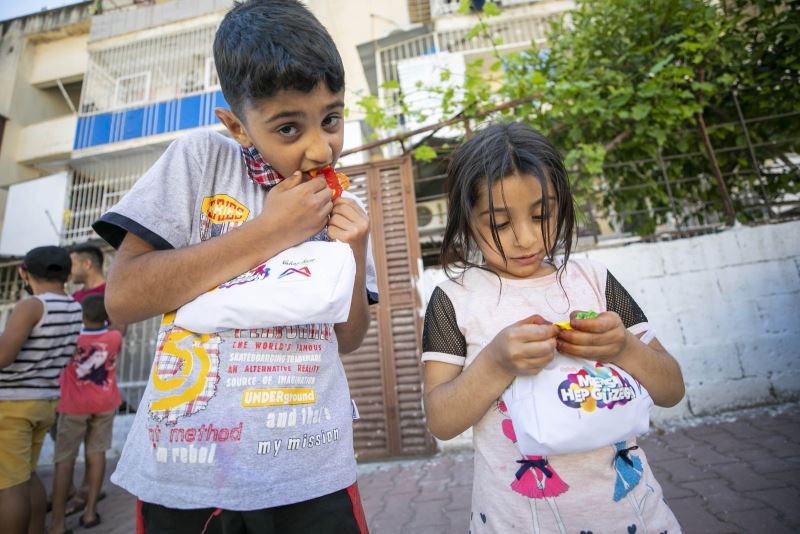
[441,122,576,280]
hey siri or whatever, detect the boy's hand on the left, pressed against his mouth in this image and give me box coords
[256,171,333,246]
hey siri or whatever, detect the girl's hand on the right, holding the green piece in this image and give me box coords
[558,311,628,363]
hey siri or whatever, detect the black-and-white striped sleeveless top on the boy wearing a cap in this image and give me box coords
[0,293,82,400]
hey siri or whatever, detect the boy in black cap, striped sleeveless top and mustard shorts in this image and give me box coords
[0,246,81,534]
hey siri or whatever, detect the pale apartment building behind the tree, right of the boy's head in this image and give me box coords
[358,0,574,266]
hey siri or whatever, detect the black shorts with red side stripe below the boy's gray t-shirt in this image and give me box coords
[137,483,369,534]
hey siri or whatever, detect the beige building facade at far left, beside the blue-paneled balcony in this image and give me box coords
[0,2,91,272]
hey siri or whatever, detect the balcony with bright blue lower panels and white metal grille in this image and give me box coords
[74,18,228,153]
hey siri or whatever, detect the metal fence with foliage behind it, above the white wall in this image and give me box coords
[415,94,800,267]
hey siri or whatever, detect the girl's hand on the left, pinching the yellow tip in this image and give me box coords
[486,315,559,377]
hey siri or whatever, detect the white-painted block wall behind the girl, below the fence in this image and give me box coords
[422,222,800,422]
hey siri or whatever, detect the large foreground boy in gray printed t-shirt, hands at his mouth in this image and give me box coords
[94,0,377,534]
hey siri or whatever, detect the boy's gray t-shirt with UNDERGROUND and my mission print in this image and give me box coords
[94,130,377,510]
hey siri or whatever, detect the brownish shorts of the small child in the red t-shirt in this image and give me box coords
[53,412,114,463]
